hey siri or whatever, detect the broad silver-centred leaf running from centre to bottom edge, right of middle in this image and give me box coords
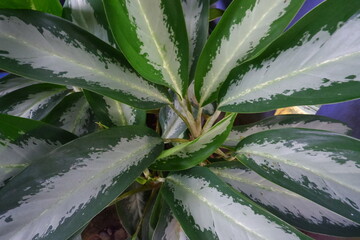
[161,167,311,240]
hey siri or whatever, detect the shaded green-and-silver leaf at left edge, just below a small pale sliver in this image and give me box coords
[0,83,69,120]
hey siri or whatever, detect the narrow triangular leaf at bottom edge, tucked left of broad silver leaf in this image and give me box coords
[152,198,189,240]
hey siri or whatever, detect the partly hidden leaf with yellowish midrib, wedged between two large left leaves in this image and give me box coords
[84,91,146,127]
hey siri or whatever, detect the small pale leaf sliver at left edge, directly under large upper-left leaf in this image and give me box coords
[0,74,38,97]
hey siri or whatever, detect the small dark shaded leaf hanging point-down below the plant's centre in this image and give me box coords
[116,183,146,235]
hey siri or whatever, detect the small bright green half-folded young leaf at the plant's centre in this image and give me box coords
[150,114,236,171]
